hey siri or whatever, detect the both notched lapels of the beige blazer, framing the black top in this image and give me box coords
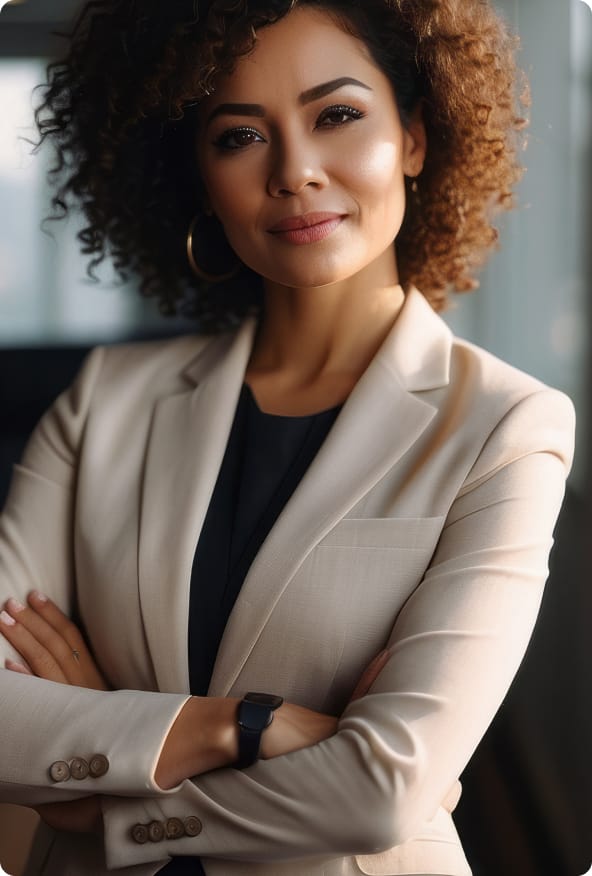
[139,289,452,695]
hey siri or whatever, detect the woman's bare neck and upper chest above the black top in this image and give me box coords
[246,254,405,415]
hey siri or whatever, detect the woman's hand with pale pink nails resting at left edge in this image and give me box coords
[0,590,109,690]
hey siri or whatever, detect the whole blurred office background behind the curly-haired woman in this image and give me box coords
[0,0,592,876]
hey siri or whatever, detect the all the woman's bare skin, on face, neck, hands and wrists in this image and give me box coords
[0,7,426,833]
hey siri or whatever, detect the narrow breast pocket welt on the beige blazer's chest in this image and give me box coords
[317,517,445,551]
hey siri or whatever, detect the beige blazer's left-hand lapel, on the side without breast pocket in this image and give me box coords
[138,320,254,692]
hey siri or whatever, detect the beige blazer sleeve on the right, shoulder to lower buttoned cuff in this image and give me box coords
[103,389,574,868]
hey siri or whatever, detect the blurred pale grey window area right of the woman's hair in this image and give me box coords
[446,0,592,481]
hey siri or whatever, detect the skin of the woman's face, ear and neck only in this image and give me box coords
[197,7,426,415]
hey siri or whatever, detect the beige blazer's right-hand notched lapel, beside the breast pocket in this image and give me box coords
[209,289,452,696]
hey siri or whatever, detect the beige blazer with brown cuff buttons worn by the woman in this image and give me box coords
[0,290,573,876]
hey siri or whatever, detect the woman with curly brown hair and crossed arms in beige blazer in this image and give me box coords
[0,0,573,876]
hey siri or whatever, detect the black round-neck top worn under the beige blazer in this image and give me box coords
[160,384,340,876]
